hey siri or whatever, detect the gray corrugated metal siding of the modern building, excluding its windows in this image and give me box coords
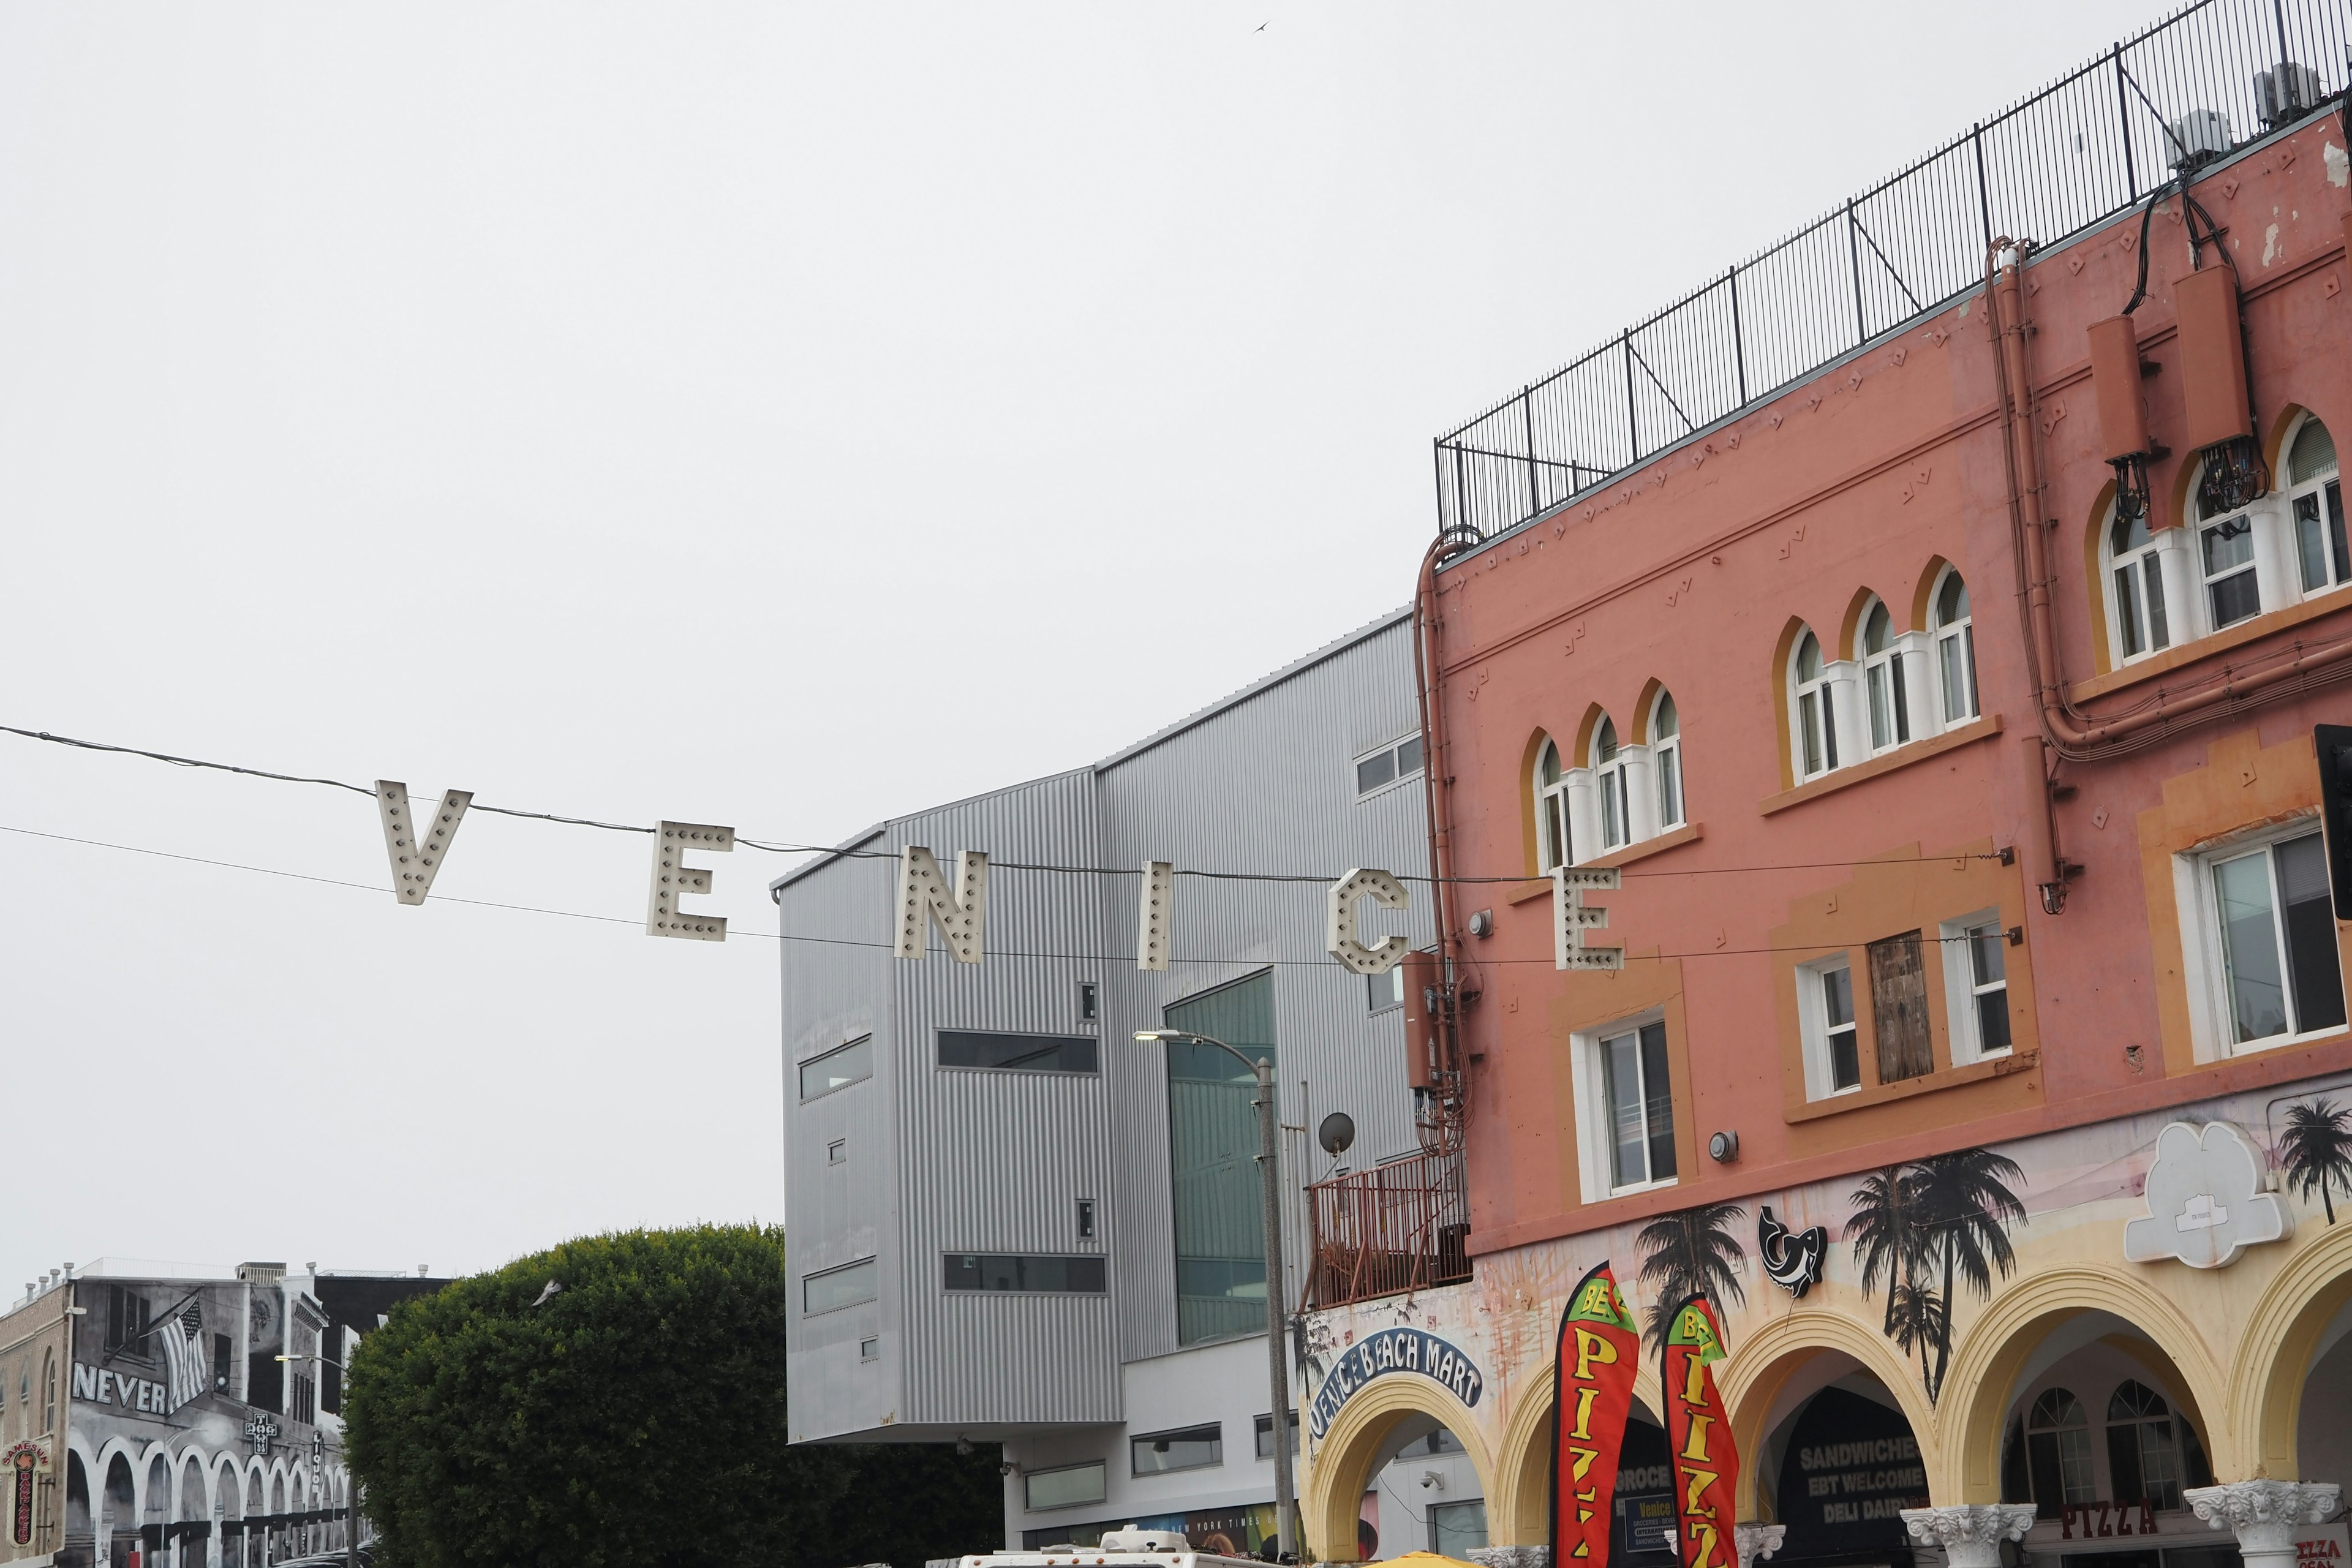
[781,620,1433,1436]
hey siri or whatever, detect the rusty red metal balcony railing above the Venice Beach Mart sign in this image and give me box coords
[1308,1154,1470,1307]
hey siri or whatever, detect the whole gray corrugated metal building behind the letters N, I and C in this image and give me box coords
[776,611,1433,1545]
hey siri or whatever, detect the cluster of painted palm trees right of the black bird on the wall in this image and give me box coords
[1846,1150,2025,1403]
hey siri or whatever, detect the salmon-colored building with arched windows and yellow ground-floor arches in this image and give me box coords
[1303,0,2352,1568]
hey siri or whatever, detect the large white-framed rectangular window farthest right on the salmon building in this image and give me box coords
[2187,818,2345,1055]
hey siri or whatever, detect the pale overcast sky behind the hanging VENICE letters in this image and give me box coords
[0,0,2154,1298]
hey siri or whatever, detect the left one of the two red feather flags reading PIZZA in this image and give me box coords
[1552,1262,1642,1568]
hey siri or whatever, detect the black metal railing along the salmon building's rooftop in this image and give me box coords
[1437,0,2352,538]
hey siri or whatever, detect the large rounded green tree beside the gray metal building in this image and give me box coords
[344,1225,1002,1568]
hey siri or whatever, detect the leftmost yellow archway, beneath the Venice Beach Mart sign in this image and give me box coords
[1298,1373,1493,1563]
